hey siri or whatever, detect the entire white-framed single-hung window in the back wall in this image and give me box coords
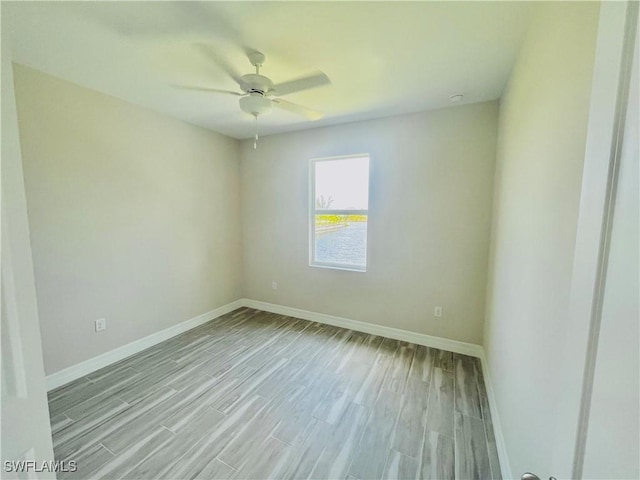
[309,155,369,272]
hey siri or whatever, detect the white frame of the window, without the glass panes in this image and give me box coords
[309,153,371,273]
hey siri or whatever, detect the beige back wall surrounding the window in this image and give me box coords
[241,102,498,343]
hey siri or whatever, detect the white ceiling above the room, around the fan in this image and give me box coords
[2,1,532,138]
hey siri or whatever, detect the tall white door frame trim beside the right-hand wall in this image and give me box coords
[552,2,638,478]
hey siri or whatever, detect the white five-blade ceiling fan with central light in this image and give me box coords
[174,45,331,129]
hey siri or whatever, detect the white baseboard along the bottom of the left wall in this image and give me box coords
[47,300,243,391]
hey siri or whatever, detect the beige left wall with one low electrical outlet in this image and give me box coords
[15,65,242,374]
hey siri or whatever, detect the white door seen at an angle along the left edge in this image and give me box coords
[0,13,56,479]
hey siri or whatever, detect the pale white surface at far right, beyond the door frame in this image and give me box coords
[583,24,640,479]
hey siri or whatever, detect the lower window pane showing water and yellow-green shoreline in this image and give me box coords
[314,215,367,268]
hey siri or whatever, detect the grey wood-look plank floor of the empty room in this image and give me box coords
[49,309,500,480]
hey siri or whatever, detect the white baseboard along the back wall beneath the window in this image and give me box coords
[241,298,483,357]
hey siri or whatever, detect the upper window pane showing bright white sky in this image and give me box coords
[315,157,369,210]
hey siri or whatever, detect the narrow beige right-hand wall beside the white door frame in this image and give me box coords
[484,2,599,478]
